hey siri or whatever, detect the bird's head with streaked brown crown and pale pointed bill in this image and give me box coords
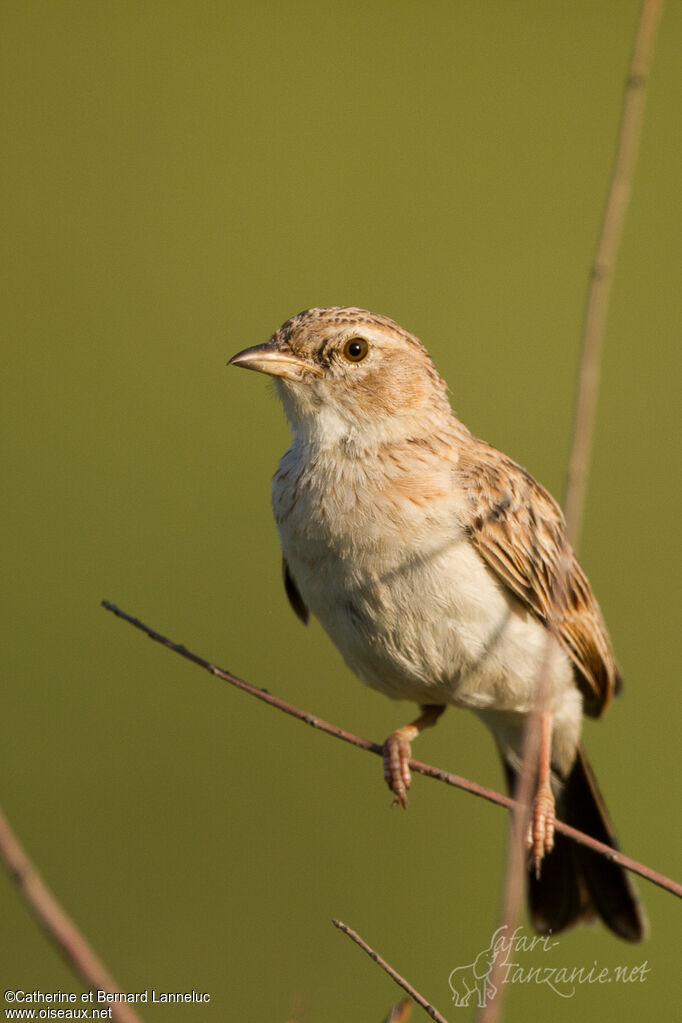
[228,307,451,443]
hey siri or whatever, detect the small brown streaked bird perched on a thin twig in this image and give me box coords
[228,306,647,941]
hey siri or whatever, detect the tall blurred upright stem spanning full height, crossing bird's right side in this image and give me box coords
[478,0,663,1023]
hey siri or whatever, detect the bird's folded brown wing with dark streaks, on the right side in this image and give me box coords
[455,441,621,717]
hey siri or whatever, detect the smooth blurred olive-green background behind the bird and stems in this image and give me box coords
[0,0,682,1023]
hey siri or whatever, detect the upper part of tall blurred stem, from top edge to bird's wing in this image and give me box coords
[564,0,663,547]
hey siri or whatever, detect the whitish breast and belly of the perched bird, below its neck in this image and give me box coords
[273,439,573,711]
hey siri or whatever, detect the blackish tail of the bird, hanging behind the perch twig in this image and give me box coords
[504,748,648,941]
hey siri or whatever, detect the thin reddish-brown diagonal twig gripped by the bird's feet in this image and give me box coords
[102,601,682,898]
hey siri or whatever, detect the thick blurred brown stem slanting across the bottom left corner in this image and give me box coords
[0,810,142,1023]
